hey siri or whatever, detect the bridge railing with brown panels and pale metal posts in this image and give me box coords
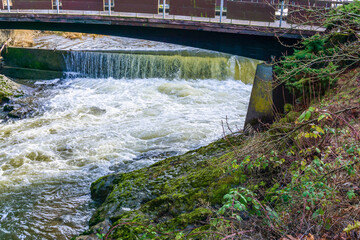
[0,0,348,29]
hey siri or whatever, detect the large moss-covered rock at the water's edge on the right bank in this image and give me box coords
[82,136,243,239]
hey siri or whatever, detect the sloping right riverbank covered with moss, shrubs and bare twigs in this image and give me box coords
[77,1,360,240]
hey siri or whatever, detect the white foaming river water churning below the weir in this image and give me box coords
[0,78,251,239]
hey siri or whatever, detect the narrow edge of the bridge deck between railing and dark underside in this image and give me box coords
[0,10,324,39]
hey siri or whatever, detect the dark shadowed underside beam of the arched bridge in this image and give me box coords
[0,14,304,61]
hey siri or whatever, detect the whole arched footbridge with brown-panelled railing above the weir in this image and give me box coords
[0,0,339,60]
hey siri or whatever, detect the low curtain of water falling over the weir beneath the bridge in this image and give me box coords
[65,51,256,80]
